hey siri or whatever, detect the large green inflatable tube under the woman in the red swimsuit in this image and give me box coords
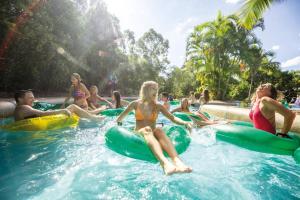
[205,123,300,160]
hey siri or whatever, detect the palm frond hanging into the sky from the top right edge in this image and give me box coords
[238,0,284,29]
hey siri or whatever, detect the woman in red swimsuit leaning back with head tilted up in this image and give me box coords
[249,83,296,137]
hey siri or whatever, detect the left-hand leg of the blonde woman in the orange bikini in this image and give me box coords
[138,126,176,175]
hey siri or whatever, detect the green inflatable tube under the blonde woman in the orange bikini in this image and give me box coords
[105,126,191,163]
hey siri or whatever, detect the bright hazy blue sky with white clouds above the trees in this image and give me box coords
[104,0,300,70]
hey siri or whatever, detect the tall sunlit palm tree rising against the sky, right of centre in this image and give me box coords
[185,12,249,99]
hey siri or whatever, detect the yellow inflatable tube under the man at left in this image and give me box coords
[0,114,79,131]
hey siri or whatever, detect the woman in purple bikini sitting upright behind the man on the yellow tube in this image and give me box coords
[62,73,90,110]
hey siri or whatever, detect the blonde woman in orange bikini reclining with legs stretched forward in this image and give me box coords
[117,81,192,175]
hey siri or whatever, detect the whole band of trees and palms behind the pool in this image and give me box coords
[0,0,300,100]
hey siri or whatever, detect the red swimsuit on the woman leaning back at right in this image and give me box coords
[249,102,276,134]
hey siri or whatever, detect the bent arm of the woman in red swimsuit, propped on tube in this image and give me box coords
[261,97,296,134]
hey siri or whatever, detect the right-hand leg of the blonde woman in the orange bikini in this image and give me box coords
[154,128,192,172]
